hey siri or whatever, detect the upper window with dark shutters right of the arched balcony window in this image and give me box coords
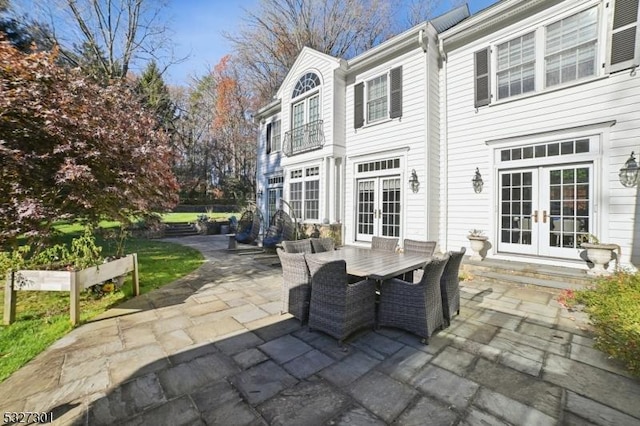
[353,67,402,129]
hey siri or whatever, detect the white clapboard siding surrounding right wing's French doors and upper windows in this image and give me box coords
[441,2,640,266]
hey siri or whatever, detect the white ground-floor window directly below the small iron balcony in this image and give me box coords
[289,166,320,221]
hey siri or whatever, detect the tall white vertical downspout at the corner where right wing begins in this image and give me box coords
[438,38,449,250]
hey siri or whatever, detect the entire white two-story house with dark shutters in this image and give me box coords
[252,0,640,268]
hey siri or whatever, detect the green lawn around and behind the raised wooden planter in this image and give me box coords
[0,228,204,381]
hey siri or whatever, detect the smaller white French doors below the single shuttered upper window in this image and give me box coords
[356,176,402,241]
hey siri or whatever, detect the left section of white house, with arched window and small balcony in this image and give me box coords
[255,6,468,244]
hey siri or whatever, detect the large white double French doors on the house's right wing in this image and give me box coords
[498,164,593,258]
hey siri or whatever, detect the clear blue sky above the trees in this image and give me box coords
[165,0,497,85]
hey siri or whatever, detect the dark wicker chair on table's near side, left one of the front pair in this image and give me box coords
[307,257,376,345]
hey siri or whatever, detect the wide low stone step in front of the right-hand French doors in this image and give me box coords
[462,257,593,289]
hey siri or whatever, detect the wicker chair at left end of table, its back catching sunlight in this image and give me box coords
[276,248,311,323]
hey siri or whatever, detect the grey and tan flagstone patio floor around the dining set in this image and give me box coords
[0,236,640,426]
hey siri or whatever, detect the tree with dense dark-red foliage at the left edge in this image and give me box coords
[0,40,177,247]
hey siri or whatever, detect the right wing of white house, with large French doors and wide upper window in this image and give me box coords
[438,0,640,268]
